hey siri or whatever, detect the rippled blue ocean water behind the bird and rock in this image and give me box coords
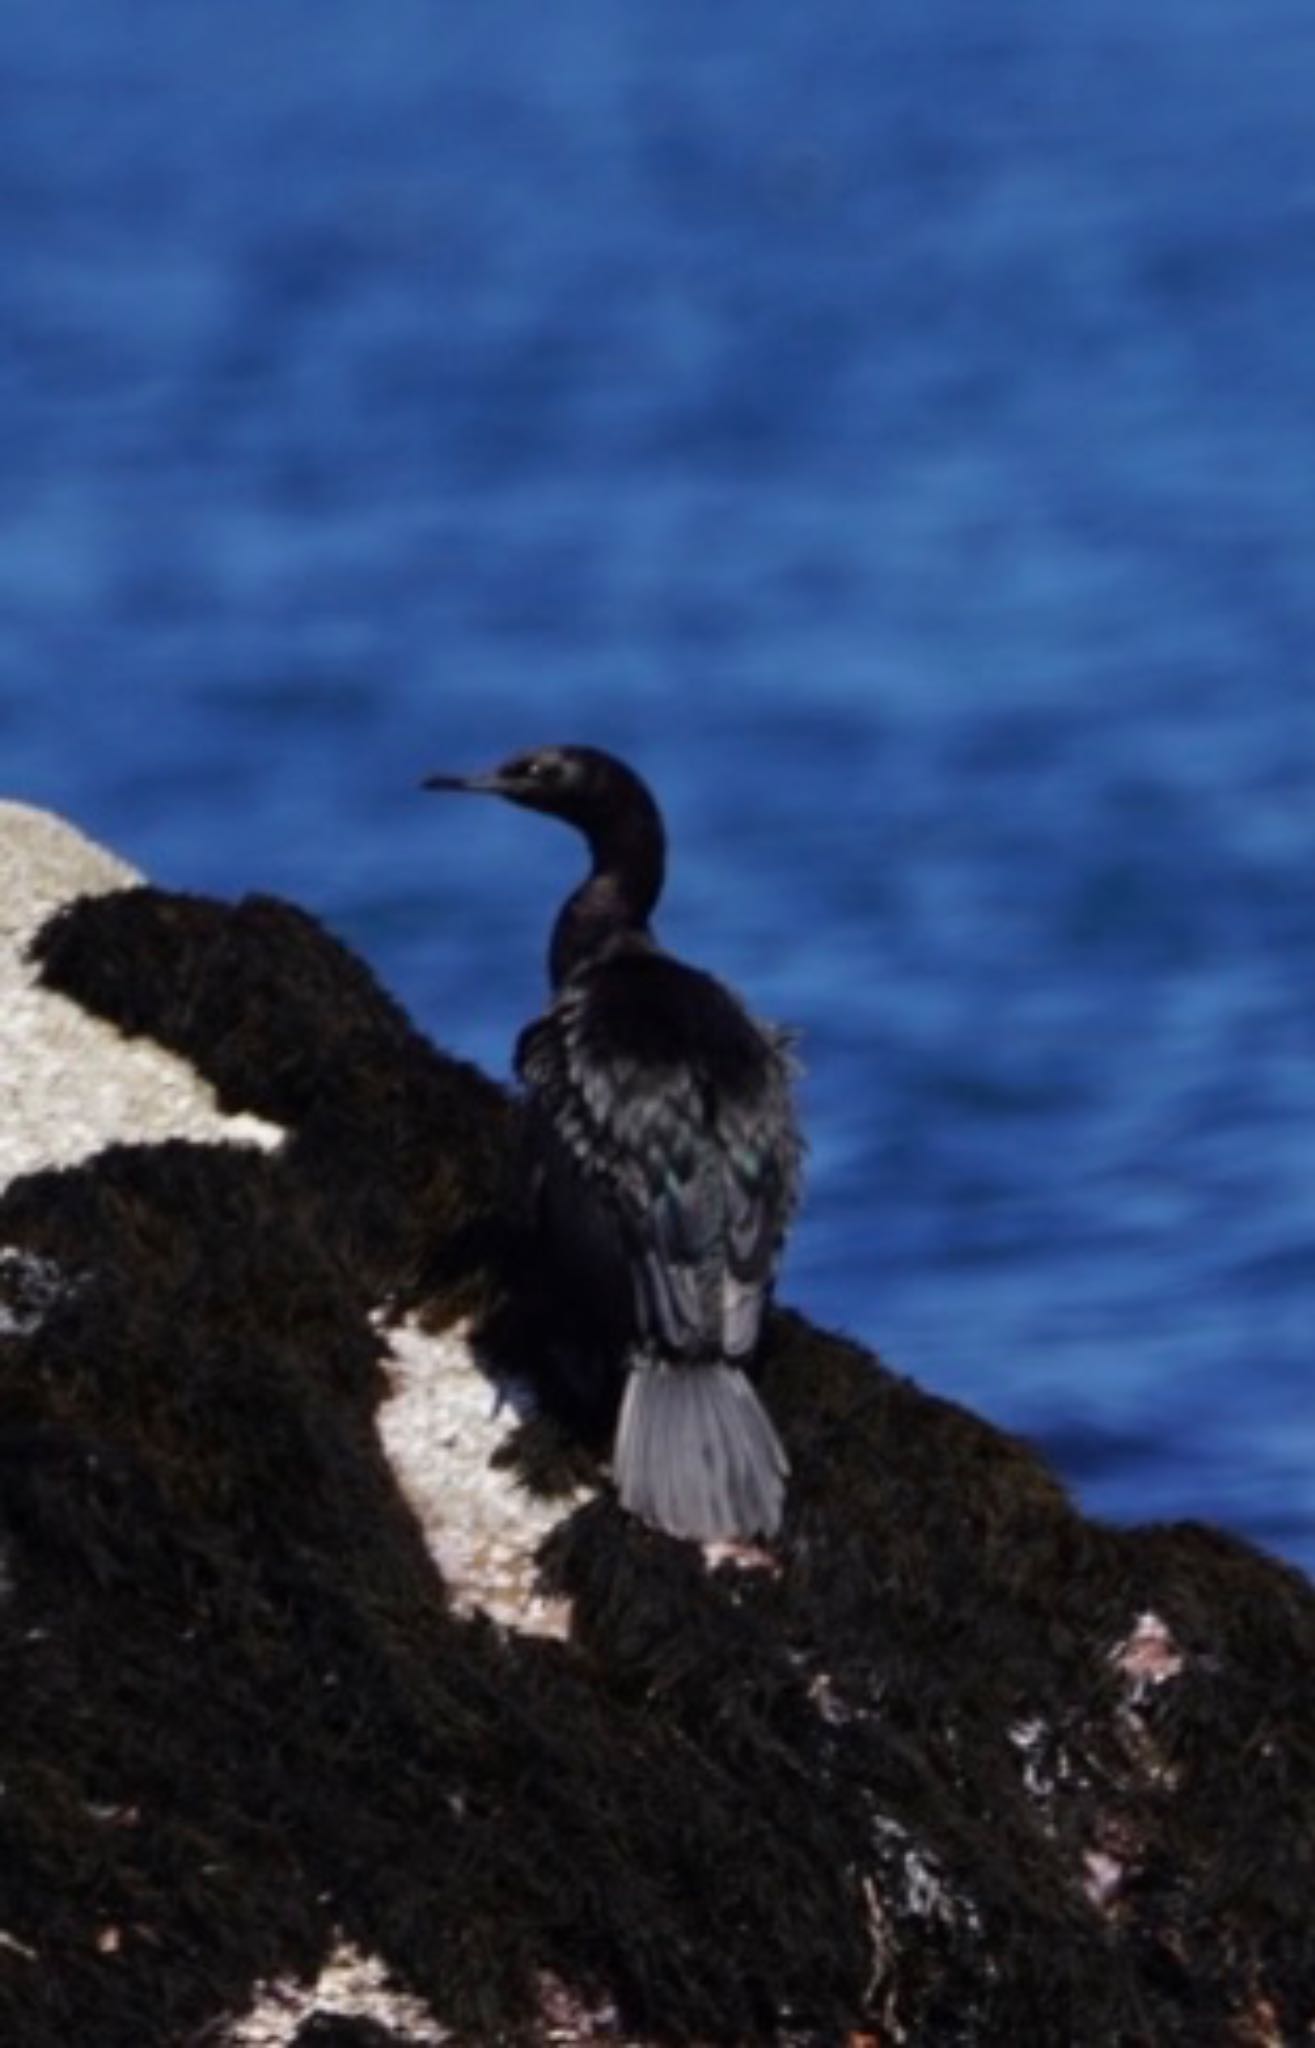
[0,0,1315,1567]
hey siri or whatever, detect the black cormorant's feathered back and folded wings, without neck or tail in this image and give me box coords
[516,942,801,1362]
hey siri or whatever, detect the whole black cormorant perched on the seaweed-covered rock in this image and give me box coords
[426,748,801,1540]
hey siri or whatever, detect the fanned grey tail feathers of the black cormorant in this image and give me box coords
[612,1358,789,1542]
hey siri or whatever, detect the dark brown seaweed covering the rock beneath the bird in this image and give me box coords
[0,856,1315,2048]
